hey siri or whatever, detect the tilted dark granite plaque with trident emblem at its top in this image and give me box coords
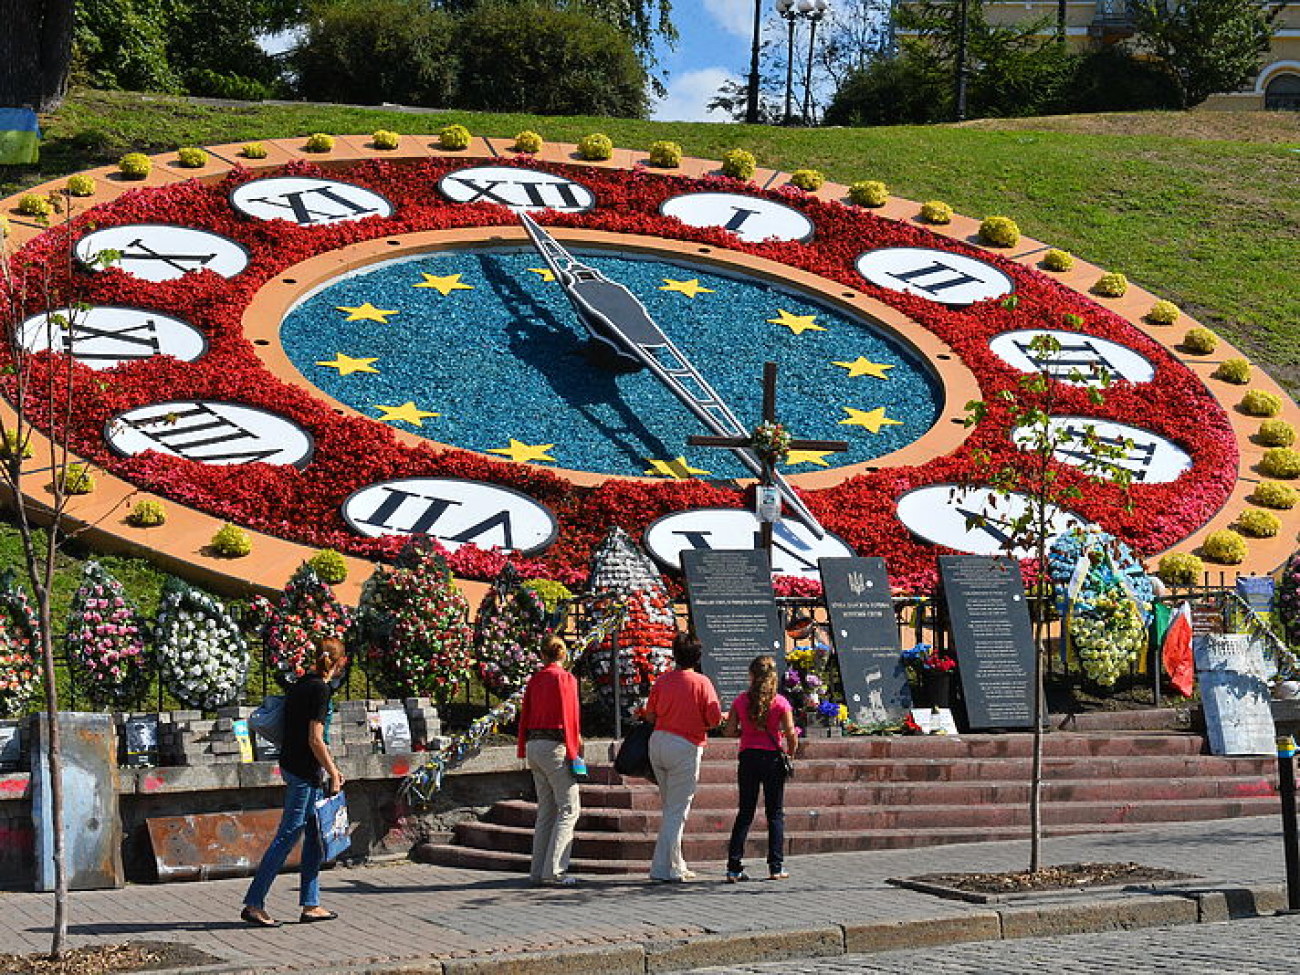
[818,558,911,724]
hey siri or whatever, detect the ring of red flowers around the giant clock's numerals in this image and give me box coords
[0,159,1238,589]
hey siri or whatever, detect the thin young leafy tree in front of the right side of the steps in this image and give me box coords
[966,330,1132,872]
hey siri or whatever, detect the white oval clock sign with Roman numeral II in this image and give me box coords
[857,247,1015,306]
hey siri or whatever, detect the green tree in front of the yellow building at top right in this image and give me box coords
[1132,0,1286,108]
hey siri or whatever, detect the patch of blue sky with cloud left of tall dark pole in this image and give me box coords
[651,0,759,122]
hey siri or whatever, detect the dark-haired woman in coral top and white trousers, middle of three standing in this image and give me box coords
[642,633,723,884]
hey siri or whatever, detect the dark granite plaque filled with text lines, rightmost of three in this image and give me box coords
[939,555,1035,731]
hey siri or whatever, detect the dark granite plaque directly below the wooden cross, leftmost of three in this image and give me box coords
[681,549,785,710]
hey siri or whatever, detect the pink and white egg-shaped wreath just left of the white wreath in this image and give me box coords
[64,562,150,707]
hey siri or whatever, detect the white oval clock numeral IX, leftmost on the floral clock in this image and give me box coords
[18,306,208,369]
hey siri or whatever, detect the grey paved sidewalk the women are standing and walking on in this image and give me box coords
[0,816,1286,975]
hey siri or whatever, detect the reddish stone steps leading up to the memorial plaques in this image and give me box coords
[434,712,1278,874]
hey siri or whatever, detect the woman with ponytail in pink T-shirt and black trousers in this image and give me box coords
[723,654,800,884]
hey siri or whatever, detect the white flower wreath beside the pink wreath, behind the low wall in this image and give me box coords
[153,580,248,711]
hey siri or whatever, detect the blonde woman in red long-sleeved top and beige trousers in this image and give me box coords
[517,637,582,887]
